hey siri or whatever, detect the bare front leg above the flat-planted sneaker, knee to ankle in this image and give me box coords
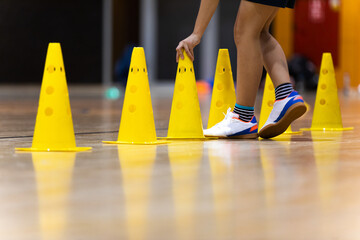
[234,1,278,107]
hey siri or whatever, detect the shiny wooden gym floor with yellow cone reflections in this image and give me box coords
[0,85,360,240]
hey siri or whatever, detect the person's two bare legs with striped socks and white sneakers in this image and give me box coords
[204,0,305,138]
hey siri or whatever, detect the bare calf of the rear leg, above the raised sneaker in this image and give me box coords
[260,11,290,87]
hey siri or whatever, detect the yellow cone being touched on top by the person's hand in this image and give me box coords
[167,51,206,140]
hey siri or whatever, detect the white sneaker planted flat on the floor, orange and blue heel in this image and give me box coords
[204,108,258,139]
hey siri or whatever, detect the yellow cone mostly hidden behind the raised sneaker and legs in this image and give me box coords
[259,74,301,134]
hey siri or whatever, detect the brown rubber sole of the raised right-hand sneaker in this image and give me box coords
[259,103,306,138]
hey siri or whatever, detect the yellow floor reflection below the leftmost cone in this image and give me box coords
[32,152,76,240]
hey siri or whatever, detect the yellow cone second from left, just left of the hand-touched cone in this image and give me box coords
[104,47,166,144]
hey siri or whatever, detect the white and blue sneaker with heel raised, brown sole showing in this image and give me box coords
[259,91,306,138]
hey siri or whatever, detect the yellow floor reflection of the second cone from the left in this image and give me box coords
[118,145,157,240]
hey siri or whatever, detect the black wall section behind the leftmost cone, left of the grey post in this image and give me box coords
[0,0,102,84]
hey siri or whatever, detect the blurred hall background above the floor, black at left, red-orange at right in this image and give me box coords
[0,0,360,90]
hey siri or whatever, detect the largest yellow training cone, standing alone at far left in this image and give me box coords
[16,43,91,152]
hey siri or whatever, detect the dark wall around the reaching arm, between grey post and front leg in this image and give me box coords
[158,0,240,80]
